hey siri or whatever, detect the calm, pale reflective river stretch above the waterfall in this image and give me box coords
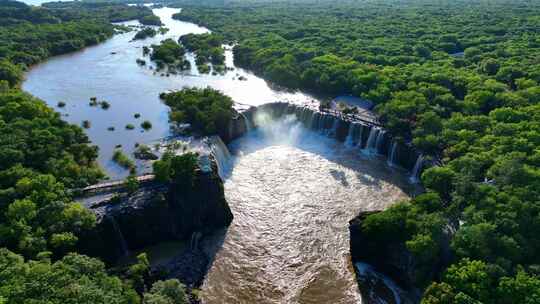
[23,8,313,179]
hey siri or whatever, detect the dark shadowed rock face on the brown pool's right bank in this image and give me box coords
[349,211,456,303]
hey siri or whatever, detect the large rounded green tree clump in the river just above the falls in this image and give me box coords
[160,87,233,135]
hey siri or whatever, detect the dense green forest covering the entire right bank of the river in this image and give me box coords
[170,0,540,303]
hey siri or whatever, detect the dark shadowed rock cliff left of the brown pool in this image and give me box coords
[79,163,233,263]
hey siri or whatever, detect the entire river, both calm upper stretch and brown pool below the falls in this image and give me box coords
[23,8,409,304]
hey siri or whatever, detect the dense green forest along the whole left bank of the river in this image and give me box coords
[0,0,187,304]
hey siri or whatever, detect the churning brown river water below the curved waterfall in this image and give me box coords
[203,120,409,304]
